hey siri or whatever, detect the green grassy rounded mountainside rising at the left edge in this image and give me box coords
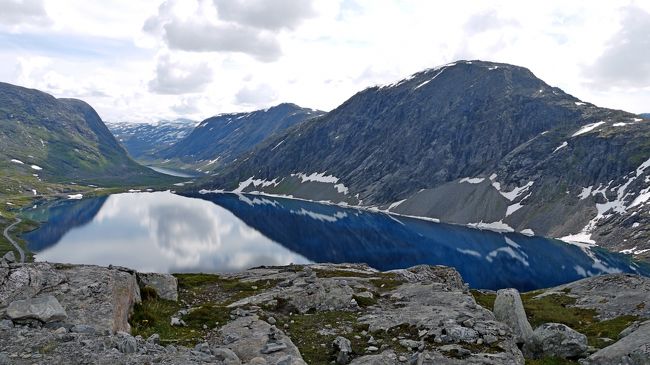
[0,83,170,186]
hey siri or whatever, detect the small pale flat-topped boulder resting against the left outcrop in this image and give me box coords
[7,295,68,323]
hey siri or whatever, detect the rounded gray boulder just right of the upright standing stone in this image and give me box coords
[523,323,587,359]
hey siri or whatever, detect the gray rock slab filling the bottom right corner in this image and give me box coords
[580,321,650,365]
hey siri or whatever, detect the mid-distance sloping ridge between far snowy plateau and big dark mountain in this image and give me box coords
[155,103,323,171]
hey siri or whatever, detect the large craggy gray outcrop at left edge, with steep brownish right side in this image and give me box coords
[0,262,140,333]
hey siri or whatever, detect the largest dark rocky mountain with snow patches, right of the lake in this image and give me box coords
[197,61,650,257]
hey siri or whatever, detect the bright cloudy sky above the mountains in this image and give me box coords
[0,0,650,122]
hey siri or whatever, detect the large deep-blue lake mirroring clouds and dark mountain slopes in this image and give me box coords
[23,192,650,290]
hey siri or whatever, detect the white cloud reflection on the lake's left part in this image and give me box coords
[37,192,309,272]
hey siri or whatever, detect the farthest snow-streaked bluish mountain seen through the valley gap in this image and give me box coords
[106,118,197,159]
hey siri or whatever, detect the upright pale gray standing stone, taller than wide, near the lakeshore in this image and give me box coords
[494,288,533,343]
